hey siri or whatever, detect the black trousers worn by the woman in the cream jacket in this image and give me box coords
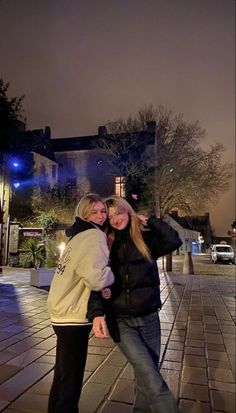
[48,325,91,413]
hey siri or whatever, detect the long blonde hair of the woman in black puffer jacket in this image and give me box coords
[104,195,152,261]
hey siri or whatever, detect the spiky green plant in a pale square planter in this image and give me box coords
[21,238,54,287]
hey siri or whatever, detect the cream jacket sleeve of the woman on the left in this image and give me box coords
[77,229,114,291]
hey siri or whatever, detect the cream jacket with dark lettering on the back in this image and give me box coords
[47,227,114,326]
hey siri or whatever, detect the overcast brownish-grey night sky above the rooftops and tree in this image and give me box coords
[0,0,235,236]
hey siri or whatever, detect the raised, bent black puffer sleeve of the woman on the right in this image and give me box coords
[147,216,182,259]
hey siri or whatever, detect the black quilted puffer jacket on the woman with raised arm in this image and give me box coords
[88,217,182,334]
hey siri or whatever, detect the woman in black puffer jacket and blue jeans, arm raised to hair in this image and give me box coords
[88,196,182,413]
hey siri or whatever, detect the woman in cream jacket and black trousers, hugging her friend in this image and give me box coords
[48,194,114,413]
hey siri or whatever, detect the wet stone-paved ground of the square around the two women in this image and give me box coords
[0,256,235,413]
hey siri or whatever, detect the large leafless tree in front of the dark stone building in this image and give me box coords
[99,106,233,216]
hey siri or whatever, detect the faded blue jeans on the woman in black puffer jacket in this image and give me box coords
[117,313,179,413]
